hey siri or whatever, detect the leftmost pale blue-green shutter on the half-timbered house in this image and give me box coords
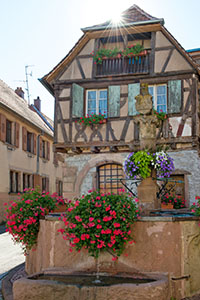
[72,83,84,118]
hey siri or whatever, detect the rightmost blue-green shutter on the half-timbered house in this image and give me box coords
[168,80,182,113]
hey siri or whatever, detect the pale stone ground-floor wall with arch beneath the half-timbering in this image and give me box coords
[64,150,200,205]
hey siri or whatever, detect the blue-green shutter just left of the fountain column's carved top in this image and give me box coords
[128,83,140,116]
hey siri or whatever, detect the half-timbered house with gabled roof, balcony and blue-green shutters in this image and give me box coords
[41,5,200,203]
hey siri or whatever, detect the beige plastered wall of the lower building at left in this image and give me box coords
[0,108,62,222]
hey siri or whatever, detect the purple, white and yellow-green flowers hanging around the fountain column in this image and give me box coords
[124,150,174,179]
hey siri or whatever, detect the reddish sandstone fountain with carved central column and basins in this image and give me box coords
[13,85,200,300]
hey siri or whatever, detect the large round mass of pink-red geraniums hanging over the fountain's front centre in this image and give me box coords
[58,190,139,260]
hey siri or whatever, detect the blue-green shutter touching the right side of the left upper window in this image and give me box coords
[108,85,120,117]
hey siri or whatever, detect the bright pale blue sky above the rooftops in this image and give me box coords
[0,0,200,118]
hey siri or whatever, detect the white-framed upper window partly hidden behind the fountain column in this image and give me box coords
[149,84,167,113]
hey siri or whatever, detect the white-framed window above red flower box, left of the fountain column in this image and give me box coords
[86,90,108,117]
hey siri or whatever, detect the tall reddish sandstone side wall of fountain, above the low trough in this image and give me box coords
[26,216,200,300]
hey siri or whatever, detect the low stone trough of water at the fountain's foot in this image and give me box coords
[13,273,169,300]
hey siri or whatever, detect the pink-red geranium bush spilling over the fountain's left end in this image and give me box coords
[5,189,64,254]
